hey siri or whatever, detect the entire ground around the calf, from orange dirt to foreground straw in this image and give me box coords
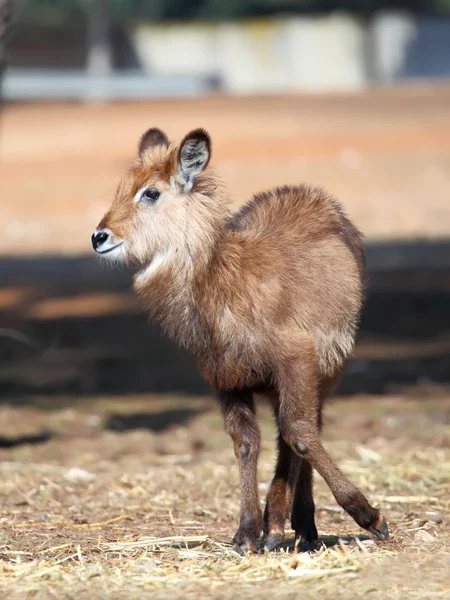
[0,85,450,600]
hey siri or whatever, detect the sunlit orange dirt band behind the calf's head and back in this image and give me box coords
[0,85,450,255]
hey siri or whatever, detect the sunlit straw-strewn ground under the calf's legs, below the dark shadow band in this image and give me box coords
[0,397,450,600]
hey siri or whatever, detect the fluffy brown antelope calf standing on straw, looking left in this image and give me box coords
[92,129,389,551]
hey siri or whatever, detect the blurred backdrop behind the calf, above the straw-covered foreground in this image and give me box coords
[0,0,450,426]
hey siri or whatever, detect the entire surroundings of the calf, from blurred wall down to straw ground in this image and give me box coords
[0,0,450,588]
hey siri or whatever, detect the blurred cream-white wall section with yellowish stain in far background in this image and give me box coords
[132,15,366,93]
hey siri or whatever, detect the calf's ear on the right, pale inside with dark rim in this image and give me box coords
[178,129,211,192]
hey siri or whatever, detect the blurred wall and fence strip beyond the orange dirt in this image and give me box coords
[4,0,450,99]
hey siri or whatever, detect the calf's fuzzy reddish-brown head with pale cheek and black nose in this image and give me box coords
[92,128,218,266]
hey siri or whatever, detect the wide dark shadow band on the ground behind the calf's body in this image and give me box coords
[0,241,450,404]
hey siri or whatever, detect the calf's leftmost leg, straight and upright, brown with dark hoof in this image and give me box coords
[220,390,263,552]
